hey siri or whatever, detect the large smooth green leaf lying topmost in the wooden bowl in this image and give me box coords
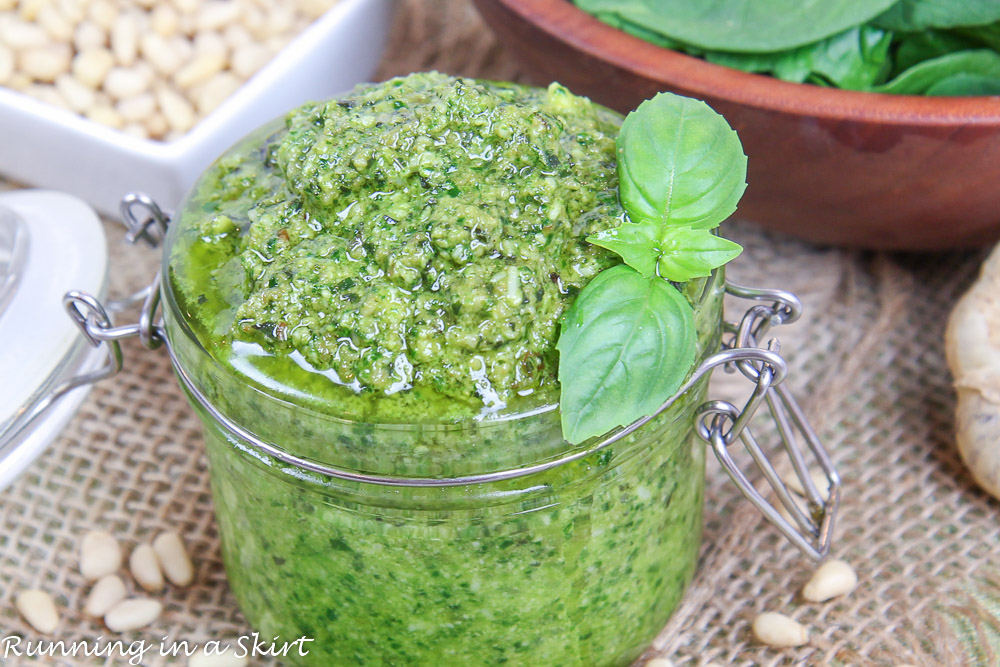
[576,0,896,53]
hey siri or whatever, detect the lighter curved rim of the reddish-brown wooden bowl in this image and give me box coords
[500,0,1000,126]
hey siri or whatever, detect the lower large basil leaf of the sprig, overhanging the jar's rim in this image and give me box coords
[556,265,695,444]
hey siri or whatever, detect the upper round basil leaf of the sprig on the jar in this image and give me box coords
[617,93,747,229]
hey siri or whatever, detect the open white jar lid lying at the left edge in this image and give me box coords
[0,190,108,489]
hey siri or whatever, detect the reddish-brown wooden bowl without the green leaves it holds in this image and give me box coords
[474,0,1000,250]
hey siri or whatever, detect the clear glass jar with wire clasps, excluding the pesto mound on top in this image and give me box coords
[48,195,840,666]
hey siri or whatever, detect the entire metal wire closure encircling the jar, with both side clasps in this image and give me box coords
[43,194,840,559]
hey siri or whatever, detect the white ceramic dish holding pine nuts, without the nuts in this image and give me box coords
[0,0,396,217]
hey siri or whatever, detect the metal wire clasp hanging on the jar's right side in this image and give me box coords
[697,283,840,560]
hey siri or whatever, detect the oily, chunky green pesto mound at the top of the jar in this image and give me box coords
[171,73,622,422]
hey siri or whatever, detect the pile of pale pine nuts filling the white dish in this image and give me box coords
[0,0,336,141]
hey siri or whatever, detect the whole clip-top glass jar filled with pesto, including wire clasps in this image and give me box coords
[41,75,837,666]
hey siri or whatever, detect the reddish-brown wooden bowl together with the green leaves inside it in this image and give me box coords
[476,0,1000,250]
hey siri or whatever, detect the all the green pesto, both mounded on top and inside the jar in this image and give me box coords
[165,74,722,667]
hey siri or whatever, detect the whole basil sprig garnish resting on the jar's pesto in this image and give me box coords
[557,93,747,443]
